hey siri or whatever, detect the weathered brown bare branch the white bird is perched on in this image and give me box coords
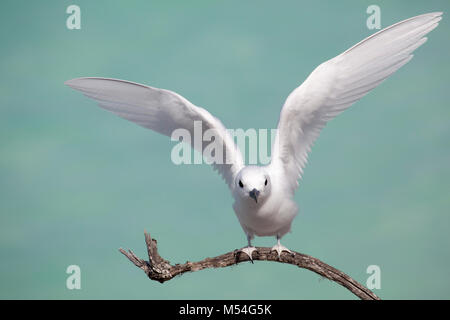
[119,232,380,300]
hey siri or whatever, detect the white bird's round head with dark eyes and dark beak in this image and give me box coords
[235,166,271,204]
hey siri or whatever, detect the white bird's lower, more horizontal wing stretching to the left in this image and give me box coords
[65,78,243,188]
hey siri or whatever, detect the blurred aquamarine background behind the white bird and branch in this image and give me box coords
[0,0,450,299]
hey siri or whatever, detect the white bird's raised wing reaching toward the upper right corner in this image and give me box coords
[271,12,442,190]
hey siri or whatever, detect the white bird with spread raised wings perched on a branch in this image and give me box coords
[65,12,442,259]
